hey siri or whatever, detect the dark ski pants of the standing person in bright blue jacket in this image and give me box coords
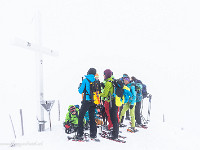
[77,100,97,137]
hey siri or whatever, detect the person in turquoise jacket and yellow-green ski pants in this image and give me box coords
[120,77,137,132]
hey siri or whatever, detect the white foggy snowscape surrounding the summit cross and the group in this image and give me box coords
[0,0,200,150]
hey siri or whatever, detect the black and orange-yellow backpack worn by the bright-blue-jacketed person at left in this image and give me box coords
[86,78,100,104]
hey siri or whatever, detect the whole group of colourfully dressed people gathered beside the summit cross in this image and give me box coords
[64,68,148,139]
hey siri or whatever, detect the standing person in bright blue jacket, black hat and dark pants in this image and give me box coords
[76,68,97,139]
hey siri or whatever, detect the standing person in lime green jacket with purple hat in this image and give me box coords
[100,69,119,139]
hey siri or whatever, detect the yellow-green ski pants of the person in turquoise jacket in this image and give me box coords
[120,103,135,127]
